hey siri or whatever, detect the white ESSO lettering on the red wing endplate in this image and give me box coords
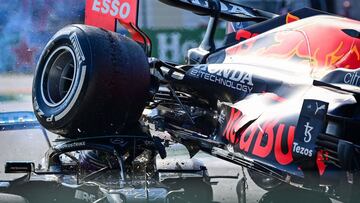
[91,0,131,19]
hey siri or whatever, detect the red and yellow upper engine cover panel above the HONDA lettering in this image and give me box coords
[225,16,360,69]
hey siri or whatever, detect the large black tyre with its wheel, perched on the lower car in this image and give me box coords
[32,25,150,138]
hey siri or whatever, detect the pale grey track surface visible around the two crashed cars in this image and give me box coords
[0,76,337,203]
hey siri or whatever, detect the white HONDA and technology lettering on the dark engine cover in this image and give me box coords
[190,65,254,93]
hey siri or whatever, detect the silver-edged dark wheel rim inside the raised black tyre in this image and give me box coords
[41,46,77,107]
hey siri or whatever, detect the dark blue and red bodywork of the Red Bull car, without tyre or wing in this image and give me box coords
[143,0,360,200]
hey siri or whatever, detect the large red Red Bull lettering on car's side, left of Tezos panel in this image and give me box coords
[223,116,296,165]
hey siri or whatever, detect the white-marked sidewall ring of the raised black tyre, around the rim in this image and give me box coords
[33,26,92,133]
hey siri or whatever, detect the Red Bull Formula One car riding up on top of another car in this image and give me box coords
[0,0,360,202]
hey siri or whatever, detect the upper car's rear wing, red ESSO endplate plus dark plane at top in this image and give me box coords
[85,0,277,56]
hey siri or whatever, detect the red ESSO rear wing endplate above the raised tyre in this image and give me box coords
[85,0,151,55]
